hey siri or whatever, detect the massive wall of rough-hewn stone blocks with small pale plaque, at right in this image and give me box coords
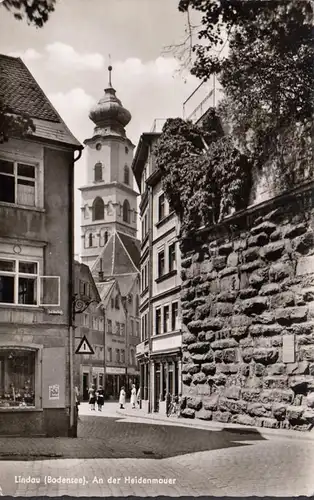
[181,184,314,430]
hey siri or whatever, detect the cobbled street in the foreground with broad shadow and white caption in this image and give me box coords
[0,403,314,497]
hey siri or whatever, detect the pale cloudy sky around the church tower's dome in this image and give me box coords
[0,0,216,254]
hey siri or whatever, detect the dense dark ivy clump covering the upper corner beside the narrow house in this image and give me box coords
[155,114,250,234]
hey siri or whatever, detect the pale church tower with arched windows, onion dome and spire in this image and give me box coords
[80,66,138,268]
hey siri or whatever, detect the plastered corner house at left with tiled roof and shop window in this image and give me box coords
[0,55,82,436]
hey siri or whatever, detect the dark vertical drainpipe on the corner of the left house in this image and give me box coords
[68,148,83,437]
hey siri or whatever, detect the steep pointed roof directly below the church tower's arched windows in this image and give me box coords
[92,231,140,281]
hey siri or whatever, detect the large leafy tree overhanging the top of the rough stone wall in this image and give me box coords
[179,0,314,184]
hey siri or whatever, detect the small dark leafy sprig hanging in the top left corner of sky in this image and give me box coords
[0,0,56,28]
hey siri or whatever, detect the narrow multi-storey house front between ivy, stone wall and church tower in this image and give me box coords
[132,132,182,412]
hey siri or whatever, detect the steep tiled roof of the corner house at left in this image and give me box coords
[0,54,83,148]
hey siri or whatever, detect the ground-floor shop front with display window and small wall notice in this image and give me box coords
[0,342,70,436]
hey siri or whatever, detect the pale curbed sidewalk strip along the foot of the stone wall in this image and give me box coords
[116,410,314,441]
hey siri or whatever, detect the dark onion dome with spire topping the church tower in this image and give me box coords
[89,66,132,129]
